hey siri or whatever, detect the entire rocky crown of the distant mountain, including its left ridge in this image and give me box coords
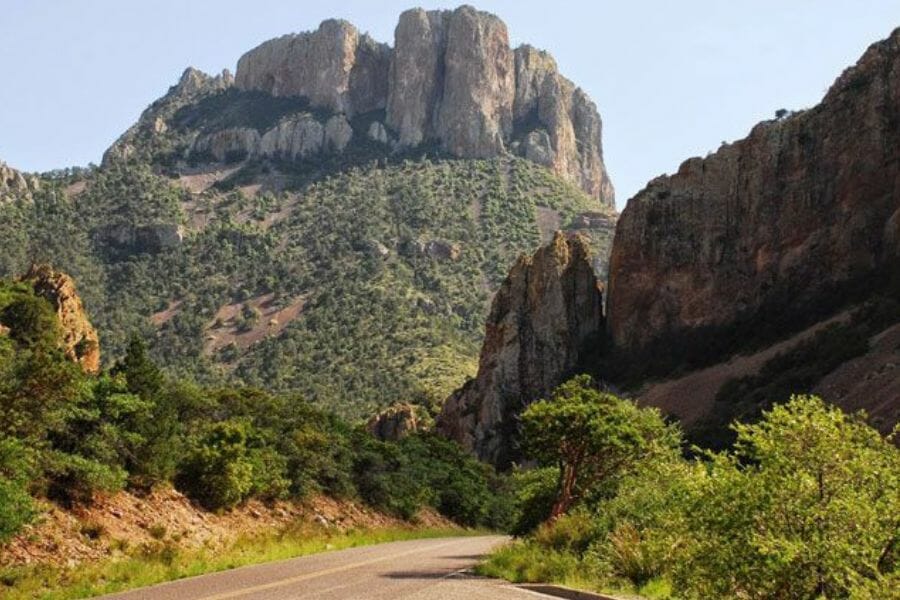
[107,6,615,208]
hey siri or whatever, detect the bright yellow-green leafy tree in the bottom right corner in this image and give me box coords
[676,396,900,598]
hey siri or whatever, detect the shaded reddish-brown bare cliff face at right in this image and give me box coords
[608,30,900,350]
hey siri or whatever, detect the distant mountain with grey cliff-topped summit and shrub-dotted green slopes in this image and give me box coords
[0,7,617,418]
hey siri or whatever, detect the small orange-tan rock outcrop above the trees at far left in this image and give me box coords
[23,265,100,373]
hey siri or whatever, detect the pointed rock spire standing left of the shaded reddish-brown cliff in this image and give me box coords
[437,233,603,468]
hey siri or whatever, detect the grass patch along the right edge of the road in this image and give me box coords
[476,540,674,600]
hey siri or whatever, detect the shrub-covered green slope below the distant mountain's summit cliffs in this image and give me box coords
[0,158,612,417]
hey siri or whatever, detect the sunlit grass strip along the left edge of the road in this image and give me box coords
[0,523,480,600]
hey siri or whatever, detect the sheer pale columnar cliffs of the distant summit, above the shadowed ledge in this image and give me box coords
[228,6,614,206]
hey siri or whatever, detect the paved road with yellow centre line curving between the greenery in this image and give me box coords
[98,536,548,600]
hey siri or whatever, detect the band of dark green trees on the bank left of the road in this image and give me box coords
[0,284,506,540]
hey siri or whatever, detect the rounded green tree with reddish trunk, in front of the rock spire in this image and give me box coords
[522,375,679,520]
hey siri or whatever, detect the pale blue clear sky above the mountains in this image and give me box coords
[0,0,900,209]
